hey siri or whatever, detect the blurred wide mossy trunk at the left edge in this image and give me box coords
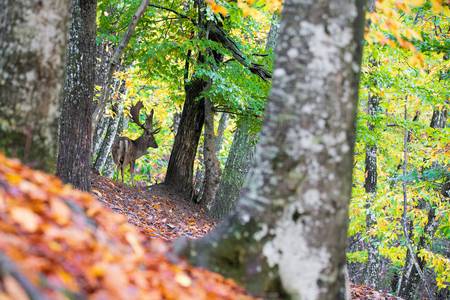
[0,0,69,171]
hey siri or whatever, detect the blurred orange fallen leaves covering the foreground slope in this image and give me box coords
[0,154,252,300]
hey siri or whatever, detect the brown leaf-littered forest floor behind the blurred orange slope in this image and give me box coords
[92,174,401,300]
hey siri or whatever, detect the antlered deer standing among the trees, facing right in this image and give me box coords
[111,101,161,185]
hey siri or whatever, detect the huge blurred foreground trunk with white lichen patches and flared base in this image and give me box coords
[178,0,363,300]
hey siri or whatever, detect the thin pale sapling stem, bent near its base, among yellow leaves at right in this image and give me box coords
[402,101,434,300]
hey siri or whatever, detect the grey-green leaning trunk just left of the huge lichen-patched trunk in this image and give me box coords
[209,117,257,220]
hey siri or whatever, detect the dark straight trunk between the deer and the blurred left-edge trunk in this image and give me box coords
[56,0,97,191]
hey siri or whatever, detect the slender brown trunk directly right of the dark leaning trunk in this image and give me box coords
[200,99,220,207]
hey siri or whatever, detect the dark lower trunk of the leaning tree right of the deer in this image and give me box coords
[164,79,207,197]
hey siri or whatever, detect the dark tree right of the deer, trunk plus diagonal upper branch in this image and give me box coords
[164,1,271,196]
